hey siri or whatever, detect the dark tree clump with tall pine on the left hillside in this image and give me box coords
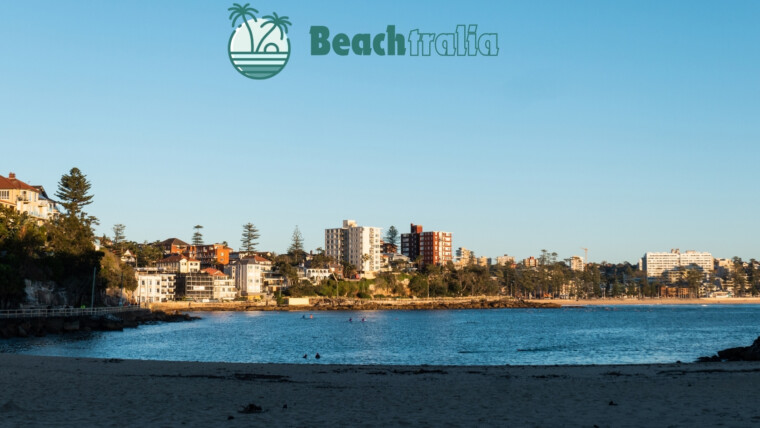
[0,168,135,308]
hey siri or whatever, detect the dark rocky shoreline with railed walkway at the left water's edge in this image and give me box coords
[0,309,199,339]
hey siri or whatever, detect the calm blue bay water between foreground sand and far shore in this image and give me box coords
[0,305,760,365]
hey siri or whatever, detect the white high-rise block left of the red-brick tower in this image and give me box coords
[325,220,382,273]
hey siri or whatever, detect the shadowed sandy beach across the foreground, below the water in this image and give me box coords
[0,354,760,427]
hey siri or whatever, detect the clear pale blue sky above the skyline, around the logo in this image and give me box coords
[0,0,760,262]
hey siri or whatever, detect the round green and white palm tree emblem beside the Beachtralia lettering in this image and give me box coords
[227,3,293,80]
